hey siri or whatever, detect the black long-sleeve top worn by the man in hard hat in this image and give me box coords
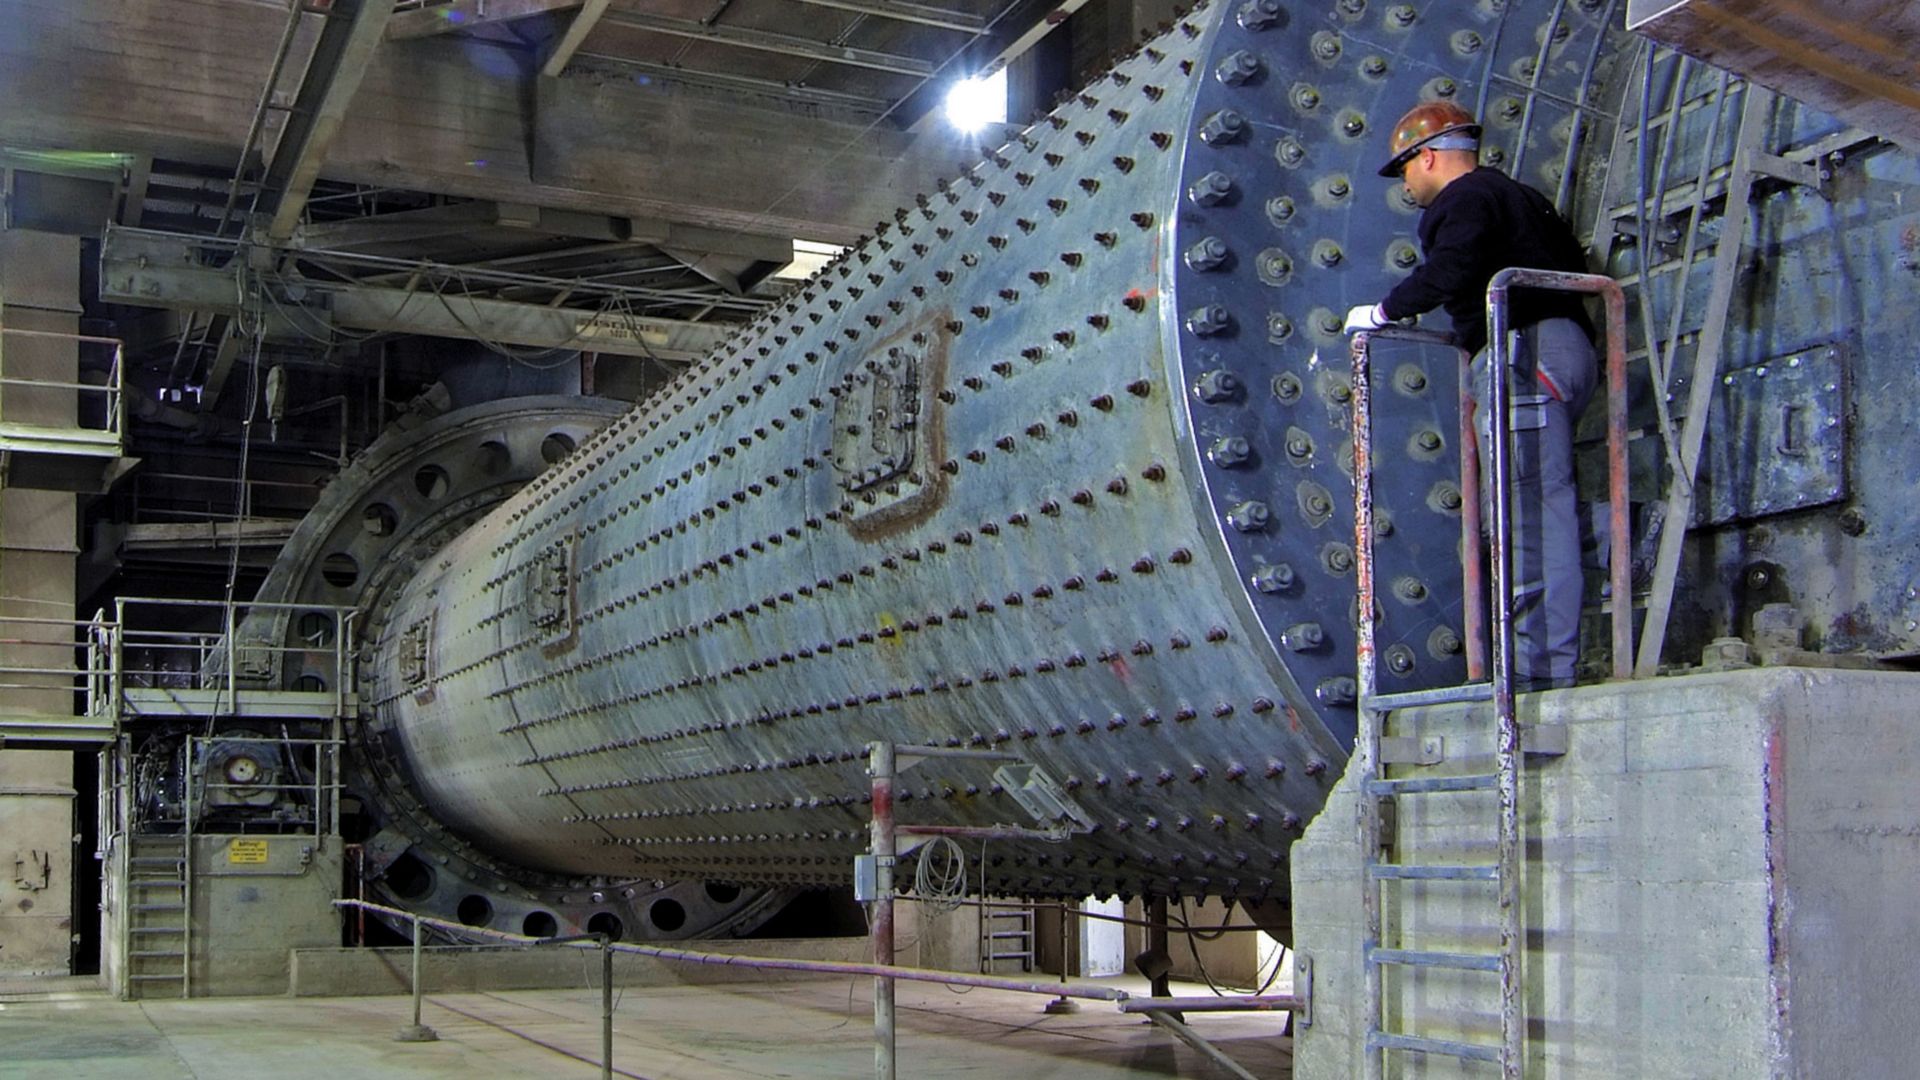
[1382,165,1594,352]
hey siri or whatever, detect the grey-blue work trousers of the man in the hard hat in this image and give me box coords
[1473,319,1597,690]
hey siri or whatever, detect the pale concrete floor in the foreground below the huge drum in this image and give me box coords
[0,978,1292,1080]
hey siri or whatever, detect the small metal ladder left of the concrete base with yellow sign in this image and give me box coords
[121,832,194,997]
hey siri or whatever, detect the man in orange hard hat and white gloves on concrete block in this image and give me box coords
[1346,102,1596,690]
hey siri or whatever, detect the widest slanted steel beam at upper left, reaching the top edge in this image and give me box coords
[261,0,394,240]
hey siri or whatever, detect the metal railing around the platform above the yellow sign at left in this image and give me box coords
[113,596,359,717]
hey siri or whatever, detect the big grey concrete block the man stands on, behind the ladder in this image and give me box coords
[1294,669,1920,1080]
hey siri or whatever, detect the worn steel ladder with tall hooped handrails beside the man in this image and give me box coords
[1352,269,1632,1080]
